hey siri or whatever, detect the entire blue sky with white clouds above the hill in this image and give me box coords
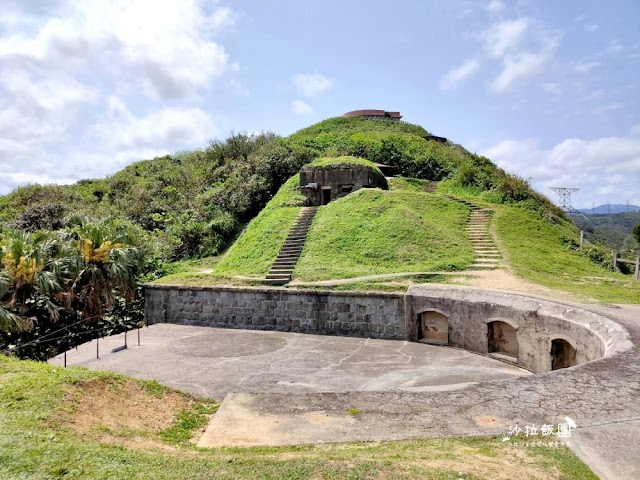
[0,0,640,207]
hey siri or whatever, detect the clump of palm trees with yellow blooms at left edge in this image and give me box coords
[0,217,142,332]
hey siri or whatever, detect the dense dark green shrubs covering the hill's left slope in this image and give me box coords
[0,133,317,260]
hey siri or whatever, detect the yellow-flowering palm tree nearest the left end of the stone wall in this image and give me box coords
[61,216,142,320]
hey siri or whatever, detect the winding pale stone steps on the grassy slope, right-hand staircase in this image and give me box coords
[445,195,502,270]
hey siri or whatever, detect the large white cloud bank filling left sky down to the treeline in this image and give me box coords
[0,0,232,194]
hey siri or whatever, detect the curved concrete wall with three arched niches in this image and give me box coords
[405,285,630,373]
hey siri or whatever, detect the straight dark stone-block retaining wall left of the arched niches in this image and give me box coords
[145,284,406,340]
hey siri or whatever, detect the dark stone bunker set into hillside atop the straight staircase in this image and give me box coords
[300,163,389,207]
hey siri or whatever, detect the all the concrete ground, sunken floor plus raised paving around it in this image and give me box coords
[51,301,640,480]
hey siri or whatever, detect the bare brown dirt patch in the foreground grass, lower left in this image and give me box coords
[51,378,205,449]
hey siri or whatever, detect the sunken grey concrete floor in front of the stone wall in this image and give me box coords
[49,324,530,400]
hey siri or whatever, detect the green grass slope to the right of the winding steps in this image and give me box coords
[492,205,640,303]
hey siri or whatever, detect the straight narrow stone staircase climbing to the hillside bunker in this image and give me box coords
[265,207,318,285]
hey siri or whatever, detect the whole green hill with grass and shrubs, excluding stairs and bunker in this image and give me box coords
[0,118,638,301]
